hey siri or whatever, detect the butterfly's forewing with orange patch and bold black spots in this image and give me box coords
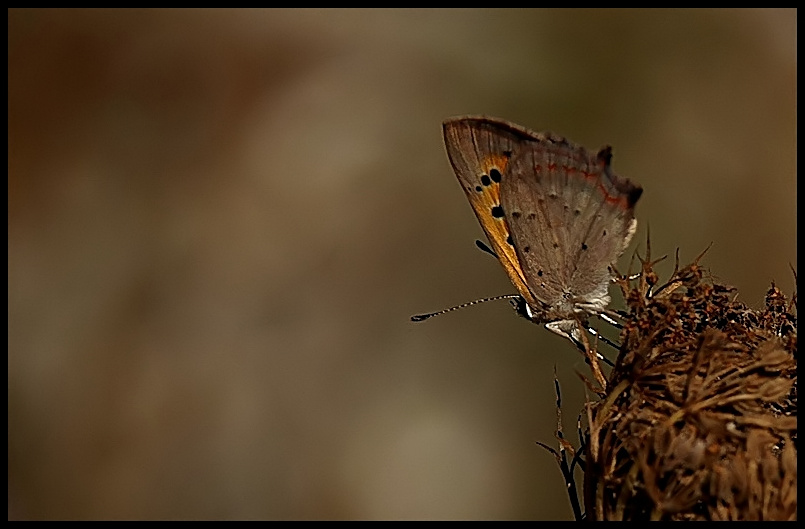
[443,117,538,306]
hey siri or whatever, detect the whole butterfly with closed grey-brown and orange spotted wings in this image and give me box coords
[413,116,643,344]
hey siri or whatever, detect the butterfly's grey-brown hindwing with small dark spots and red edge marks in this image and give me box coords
[500,134,642,318]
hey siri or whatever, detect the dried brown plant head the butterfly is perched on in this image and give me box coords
[540,242,797,520]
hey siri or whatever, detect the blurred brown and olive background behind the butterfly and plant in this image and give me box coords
[8,10,797,519]
